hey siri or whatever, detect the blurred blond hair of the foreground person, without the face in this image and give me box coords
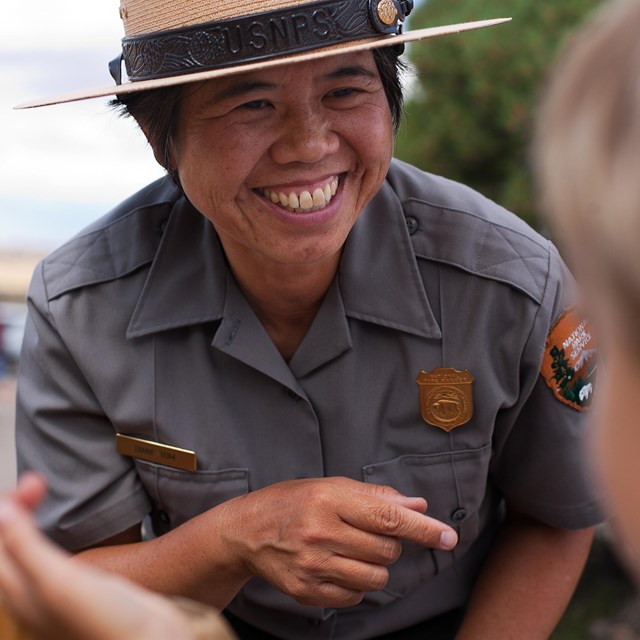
[536,0,640,356]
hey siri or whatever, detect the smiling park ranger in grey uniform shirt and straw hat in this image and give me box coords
[17,0,600,640]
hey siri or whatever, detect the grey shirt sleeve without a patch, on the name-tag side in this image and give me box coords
[16,264,150,550]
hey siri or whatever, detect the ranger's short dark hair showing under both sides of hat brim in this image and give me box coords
[110,45,406,184]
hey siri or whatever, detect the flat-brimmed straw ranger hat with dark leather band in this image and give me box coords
[16,0,509,109]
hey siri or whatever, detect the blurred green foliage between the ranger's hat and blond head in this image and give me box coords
[396,0,600,226]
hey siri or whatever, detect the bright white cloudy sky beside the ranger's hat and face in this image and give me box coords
[0,0,162,250]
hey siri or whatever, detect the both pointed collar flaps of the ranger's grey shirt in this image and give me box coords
[127,182,441,339]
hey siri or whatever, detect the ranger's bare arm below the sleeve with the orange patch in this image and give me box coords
[456,516,593,640]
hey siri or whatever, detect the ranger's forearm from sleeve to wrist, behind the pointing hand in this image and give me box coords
[77,504,251,609]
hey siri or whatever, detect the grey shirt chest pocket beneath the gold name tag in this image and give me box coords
[136,460,249,535]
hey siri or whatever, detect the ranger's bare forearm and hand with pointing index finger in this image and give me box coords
[77,478,457,608]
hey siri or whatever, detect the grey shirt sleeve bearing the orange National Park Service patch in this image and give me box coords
[491,246,603,529]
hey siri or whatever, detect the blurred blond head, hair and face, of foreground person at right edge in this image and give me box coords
[535,0,640,580]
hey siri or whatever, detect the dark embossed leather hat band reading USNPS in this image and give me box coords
[111,0,413,84]
